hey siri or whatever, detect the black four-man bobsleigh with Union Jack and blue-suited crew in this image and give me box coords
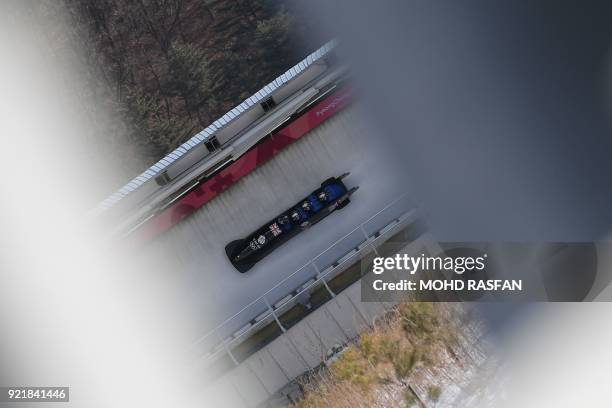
[225,173,359,273]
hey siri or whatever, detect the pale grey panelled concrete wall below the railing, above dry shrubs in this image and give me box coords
[205,240,438,408]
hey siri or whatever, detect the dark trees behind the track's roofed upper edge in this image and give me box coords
[30,0,326,198]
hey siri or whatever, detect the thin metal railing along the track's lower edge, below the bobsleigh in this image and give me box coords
[193,194,416,365]
